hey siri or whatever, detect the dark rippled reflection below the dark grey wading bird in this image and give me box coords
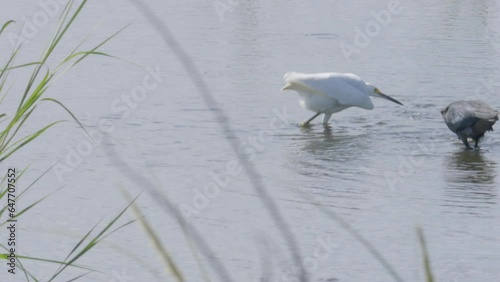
[445,151,497,212]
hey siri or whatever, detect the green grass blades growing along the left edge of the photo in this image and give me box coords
[0,0,134,281]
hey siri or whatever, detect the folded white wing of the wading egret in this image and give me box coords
[283,72,373,109]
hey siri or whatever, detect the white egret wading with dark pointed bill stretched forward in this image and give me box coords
[281,72,403,126]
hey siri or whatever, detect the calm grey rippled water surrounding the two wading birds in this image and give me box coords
[0,0,500,282]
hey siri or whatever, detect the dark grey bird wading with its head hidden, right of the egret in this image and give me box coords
[441,100,498,150]
